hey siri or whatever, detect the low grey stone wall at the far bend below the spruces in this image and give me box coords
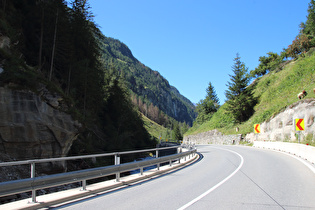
[183,130,241,145]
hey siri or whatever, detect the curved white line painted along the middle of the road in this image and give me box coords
[178,147,244,210]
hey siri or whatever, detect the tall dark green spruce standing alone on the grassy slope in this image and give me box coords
[225,53,255,123]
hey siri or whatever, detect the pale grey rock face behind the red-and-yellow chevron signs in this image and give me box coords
[245,99,315,141]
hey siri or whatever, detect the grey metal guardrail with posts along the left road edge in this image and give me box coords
[0,146,196,202]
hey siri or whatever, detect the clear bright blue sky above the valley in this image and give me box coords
[89,0,310,104]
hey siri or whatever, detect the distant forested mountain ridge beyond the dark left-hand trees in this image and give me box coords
[101,37,196,125]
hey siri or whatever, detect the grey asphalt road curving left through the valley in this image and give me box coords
[56,145,315,210]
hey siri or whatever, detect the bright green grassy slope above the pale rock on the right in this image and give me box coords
[185,53,315,135]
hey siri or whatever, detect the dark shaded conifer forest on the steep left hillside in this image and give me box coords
[0,0,160,155]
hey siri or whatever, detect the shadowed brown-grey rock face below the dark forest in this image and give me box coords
[0,87,81,160]
